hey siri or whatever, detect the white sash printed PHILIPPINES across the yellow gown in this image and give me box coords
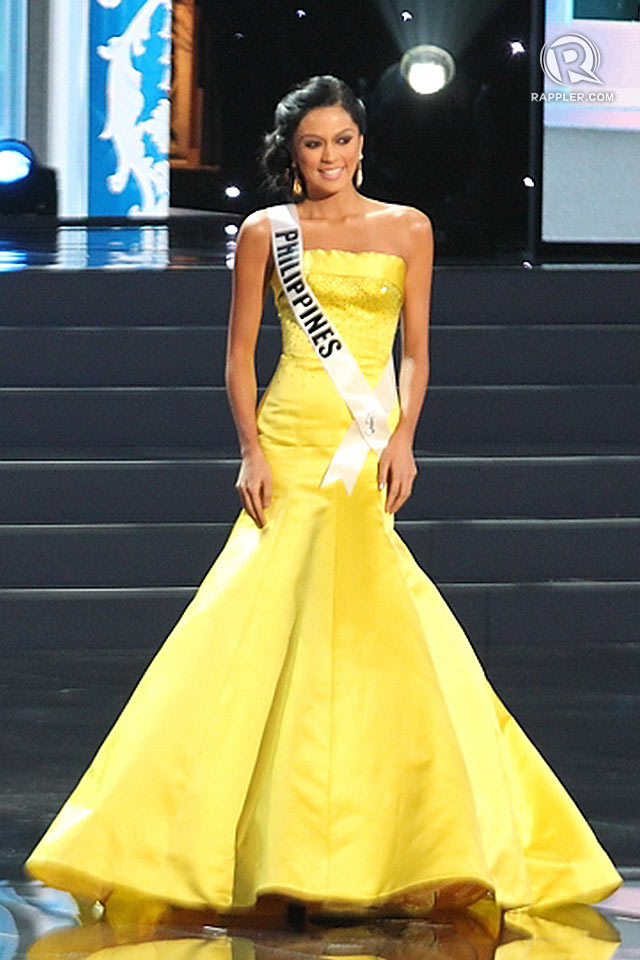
[267,203,397,493]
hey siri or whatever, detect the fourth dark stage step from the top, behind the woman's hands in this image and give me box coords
[0,449,640,524]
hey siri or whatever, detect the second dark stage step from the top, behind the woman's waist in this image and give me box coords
[0,321,640,387]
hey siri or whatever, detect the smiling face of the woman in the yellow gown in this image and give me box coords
[293,104,363,197]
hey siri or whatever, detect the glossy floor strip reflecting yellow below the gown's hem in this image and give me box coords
[0,882,640,960]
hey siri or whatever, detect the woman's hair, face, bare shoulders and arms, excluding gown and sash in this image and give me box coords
[227,79,433,526]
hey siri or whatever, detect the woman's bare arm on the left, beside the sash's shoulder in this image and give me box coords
[225,210,271,527]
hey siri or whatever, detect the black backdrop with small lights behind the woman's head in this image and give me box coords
[188,0,537,251]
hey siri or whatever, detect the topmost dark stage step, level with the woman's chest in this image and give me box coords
[0,264,640,327]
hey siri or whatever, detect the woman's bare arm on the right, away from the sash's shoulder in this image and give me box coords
[378,207,434,513]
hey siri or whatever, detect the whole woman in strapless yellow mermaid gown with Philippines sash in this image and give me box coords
[27,77,621,928]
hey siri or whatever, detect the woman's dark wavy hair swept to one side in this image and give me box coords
[259,74,367,202]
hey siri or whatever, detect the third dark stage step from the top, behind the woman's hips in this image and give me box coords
[0,385,640,449]
